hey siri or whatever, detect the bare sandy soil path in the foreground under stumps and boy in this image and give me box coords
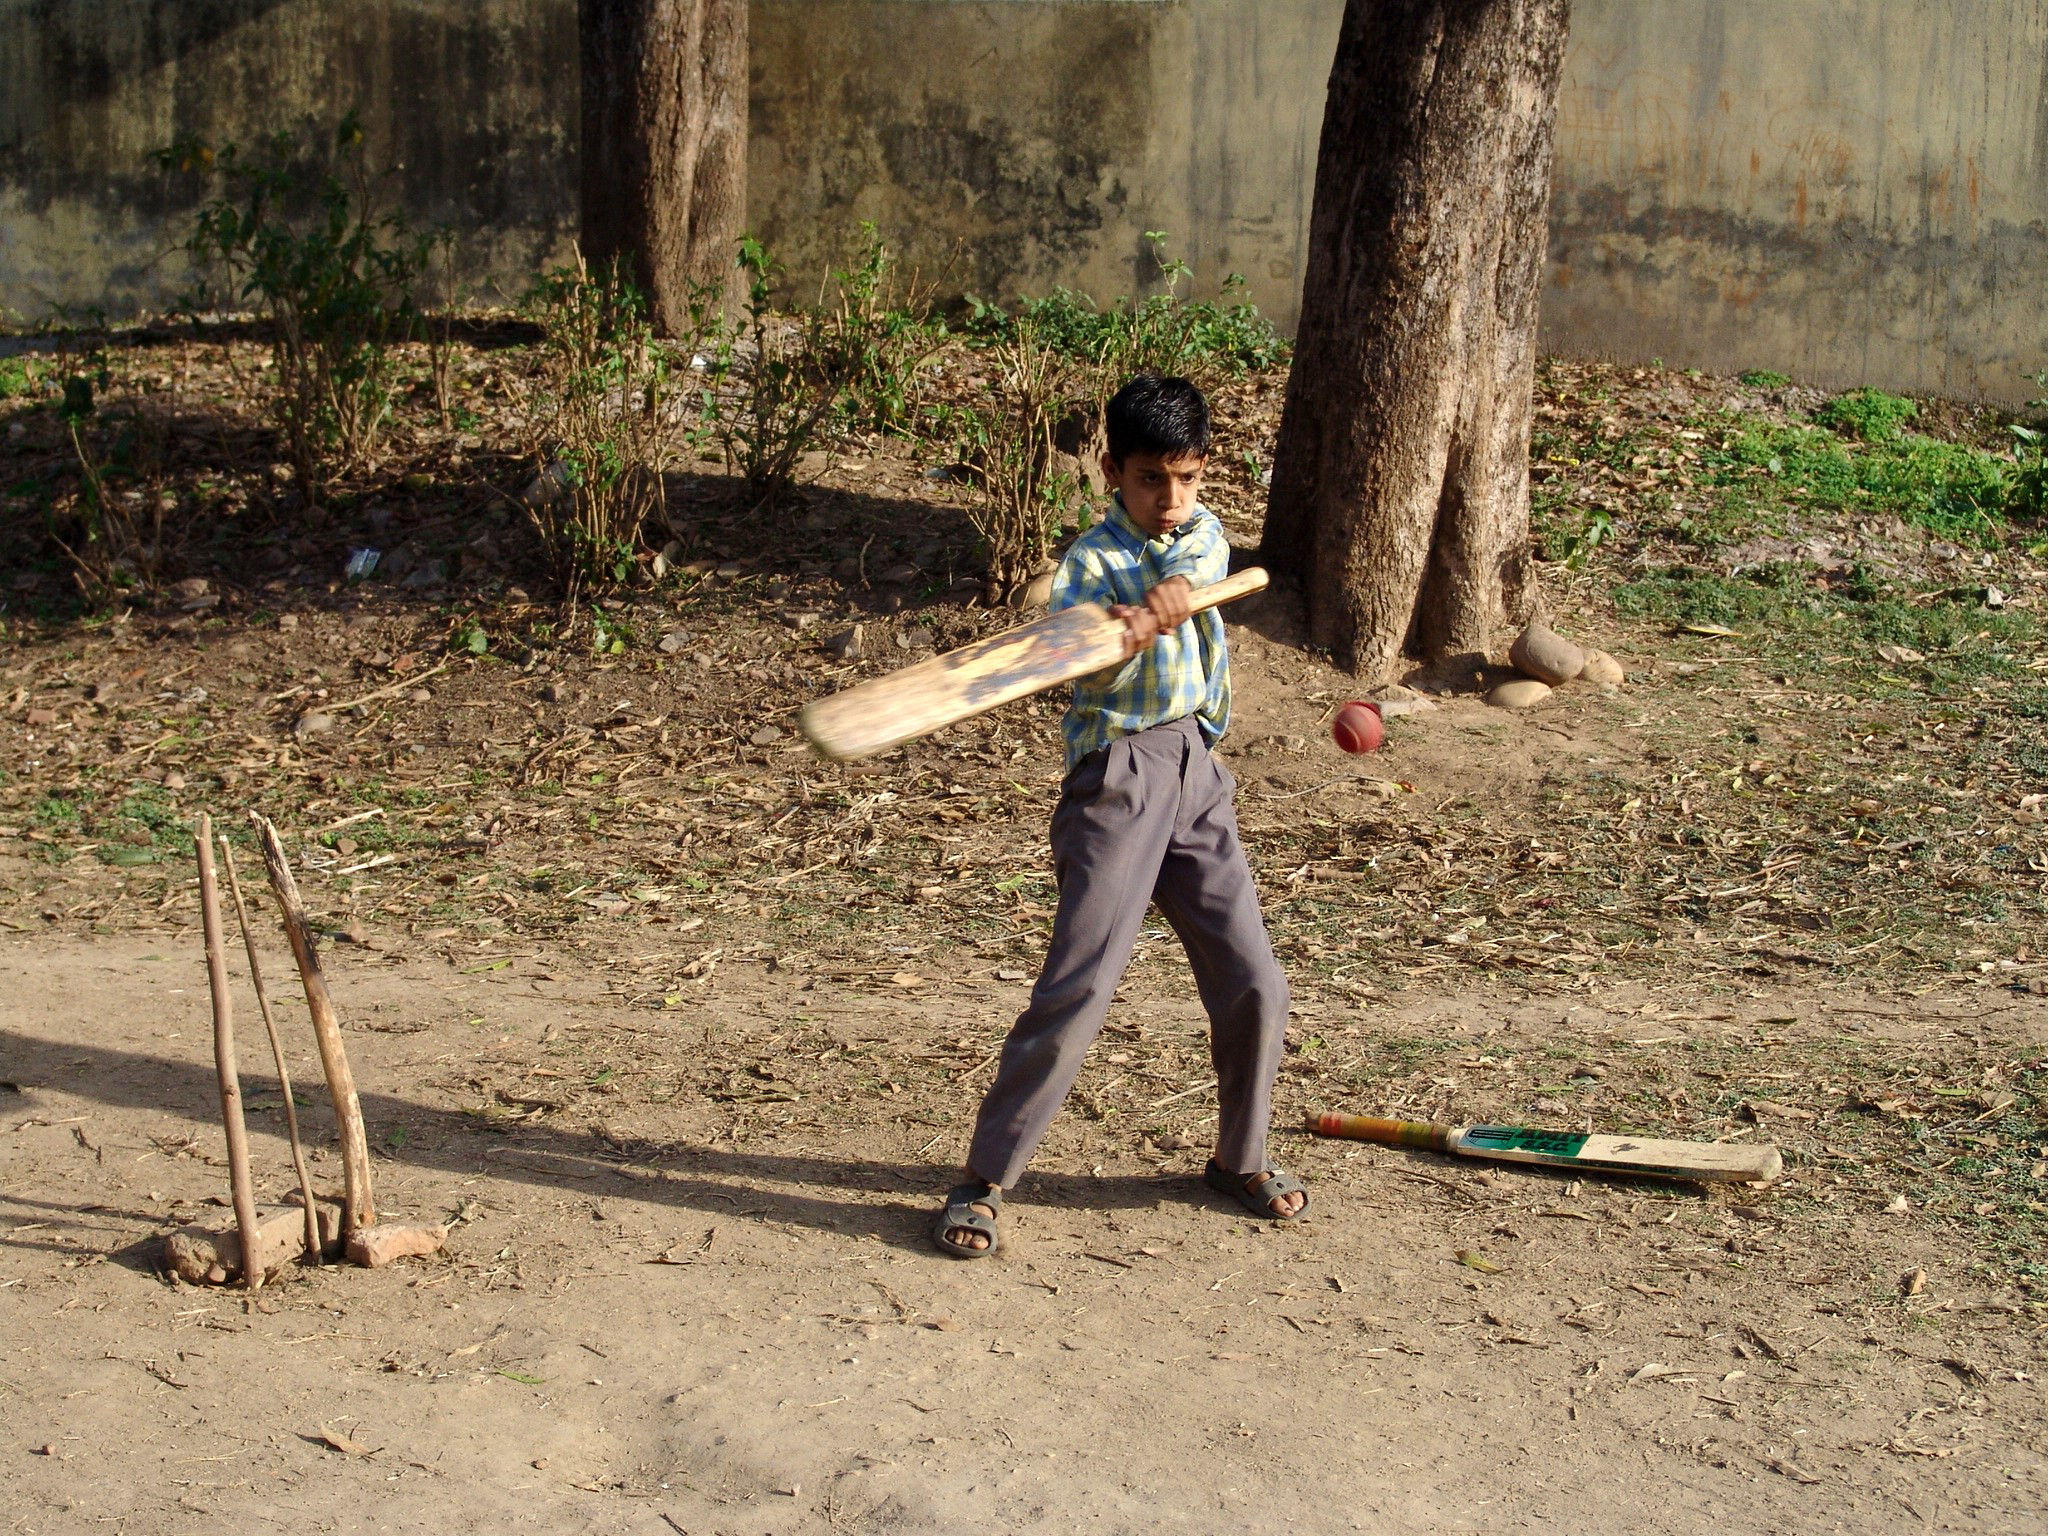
[0,932,2048,1534]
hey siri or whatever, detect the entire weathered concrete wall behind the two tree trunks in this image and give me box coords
[0,0,2048,399]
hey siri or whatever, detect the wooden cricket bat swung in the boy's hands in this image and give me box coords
[801,567,1266,762]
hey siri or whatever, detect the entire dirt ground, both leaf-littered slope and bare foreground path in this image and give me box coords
[0,342,2048,1536]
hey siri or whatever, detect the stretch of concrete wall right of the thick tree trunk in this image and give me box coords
[1542,0,2048,399]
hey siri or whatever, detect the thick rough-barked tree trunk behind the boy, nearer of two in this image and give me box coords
[1262,0,1569,682]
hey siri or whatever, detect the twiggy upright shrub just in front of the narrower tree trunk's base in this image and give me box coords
[526,256,676,600]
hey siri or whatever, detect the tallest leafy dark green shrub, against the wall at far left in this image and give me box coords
[156,113,430,502]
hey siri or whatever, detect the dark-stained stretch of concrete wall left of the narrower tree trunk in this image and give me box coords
[0,0,578,317]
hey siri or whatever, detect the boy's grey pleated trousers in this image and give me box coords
[967,719,1288,1188]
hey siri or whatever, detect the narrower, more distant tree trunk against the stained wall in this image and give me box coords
[578,0,748,336]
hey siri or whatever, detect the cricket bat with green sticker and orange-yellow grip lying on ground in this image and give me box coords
[1307,1110,1784,1184]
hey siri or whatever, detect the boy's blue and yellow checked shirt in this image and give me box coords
[1051,498,1231,768]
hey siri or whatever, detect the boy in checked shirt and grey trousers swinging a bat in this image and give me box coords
[932,375,1309,1260]
